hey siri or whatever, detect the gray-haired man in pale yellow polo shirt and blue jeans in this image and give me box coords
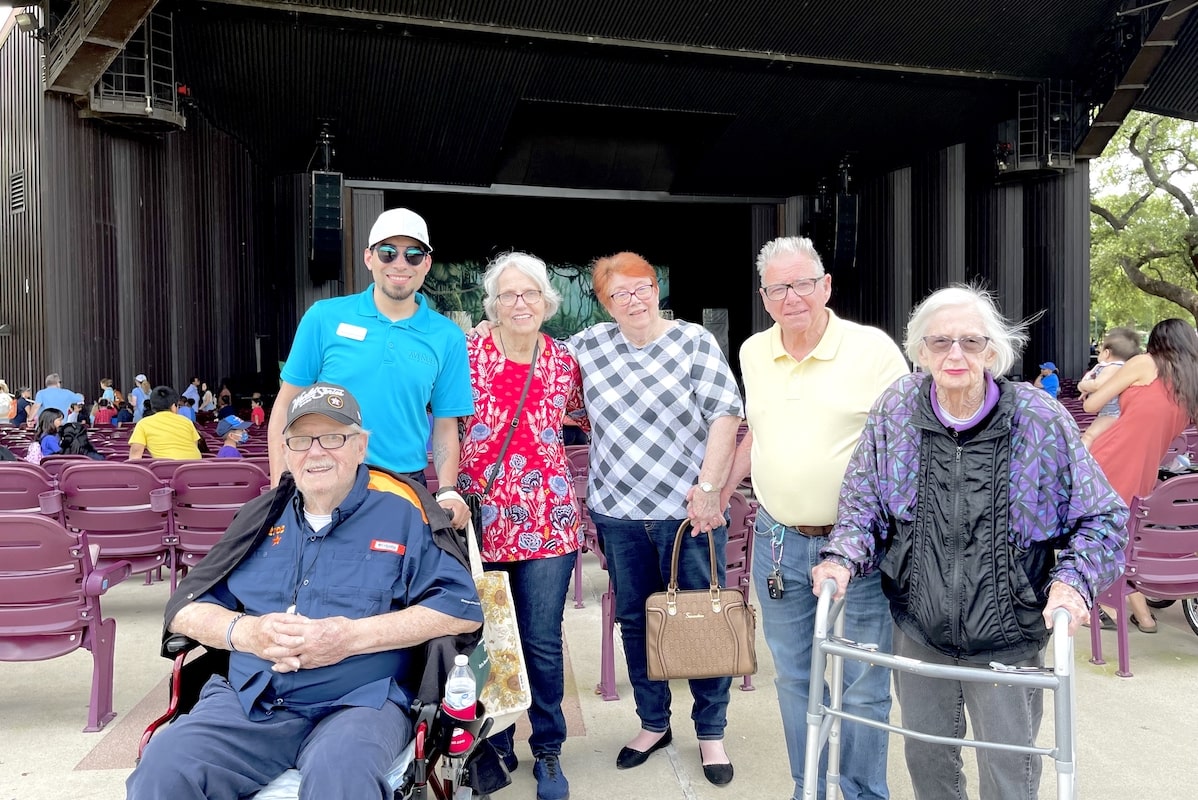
[724,236,908,800]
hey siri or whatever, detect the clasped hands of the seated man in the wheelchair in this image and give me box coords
[238,612,352,672]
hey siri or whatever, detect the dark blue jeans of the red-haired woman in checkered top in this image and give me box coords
[591,511,732,740]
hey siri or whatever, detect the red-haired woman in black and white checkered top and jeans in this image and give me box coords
[569,253,744,784]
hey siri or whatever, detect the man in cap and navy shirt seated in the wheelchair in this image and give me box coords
[127,383,483,800]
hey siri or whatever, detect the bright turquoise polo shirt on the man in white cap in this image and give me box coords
[282,284,474,472]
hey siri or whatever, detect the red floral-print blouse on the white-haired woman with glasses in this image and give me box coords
[458,335,591,562]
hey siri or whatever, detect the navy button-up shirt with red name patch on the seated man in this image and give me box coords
[196,467,483,720]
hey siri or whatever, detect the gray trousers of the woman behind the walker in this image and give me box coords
[894,626,1043,800]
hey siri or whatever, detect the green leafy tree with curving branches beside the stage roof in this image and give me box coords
[1090,111,1198,334]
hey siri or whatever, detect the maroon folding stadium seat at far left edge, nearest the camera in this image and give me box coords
[0,514,129,732]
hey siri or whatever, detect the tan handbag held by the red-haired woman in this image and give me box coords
[645,520,757,680]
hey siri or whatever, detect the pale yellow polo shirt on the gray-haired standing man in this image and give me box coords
[740,309,909,526]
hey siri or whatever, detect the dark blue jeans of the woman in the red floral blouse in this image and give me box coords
[486,553,575,758]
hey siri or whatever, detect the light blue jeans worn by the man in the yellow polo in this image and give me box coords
[752,507,894,800]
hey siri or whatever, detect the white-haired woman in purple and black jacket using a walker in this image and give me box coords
[812,286,1127,800]
